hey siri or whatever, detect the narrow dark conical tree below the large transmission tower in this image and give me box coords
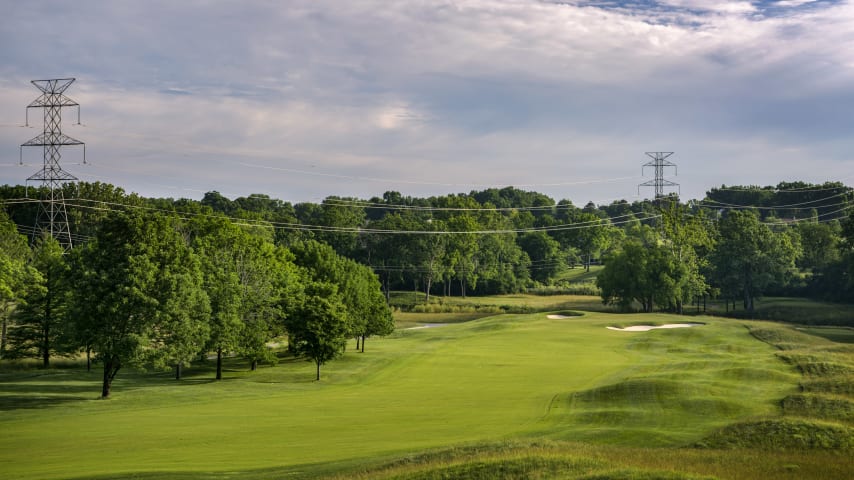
[10,236,69,368]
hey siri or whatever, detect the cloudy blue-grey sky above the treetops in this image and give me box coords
[0,0,854,205]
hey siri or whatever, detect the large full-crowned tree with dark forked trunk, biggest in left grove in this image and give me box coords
[69,213,209,398]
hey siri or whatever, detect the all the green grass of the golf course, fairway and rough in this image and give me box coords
[0,310,854,479]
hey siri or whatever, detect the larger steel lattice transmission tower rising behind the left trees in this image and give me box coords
[20,78,86,251]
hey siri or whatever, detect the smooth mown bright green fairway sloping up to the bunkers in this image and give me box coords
[0,314,797,479]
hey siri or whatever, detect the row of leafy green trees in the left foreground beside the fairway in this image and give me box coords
[0,211,394,398]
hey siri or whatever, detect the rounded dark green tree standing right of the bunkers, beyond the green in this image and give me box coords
[710,210,800,312]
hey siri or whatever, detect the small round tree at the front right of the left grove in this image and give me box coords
[285,282,348,381]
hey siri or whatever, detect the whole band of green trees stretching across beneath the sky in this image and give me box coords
[0,182,854,396]
